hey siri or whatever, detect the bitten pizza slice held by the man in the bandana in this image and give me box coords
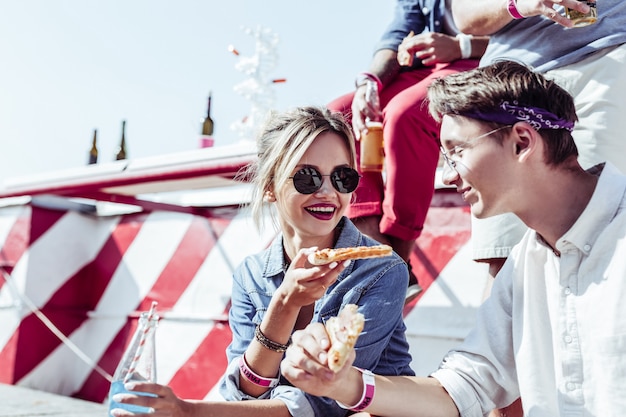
[326,304,365,372]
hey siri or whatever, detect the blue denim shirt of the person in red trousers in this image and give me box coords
[374,0,446,52]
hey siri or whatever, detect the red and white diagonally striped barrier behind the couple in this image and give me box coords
[0,146,486,402]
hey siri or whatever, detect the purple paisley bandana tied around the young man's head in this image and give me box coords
[461,100,574,132]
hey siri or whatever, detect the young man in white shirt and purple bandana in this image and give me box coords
[281,61,626,417]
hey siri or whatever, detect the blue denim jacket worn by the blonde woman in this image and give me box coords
[220,217,414,417]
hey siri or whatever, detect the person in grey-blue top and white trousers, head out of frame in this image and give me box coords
[452,4,626,417]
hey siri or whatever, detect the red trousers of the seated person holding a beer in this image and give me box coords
[328,59,478,240]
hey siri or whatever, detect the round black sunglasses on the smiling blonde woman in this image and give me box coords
[289,167,361,194]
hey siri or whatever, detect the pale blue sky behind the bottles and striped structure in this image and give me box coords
[0,0,395,184]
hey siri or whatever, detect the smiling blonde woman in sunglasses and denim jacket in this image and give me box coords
[111,107,413,417]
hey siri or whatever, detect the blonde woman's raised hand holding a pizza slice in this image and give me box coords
[276,248,350,307]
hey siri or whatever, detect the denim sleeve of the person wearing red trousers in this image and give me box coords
[374,0,428,52]
